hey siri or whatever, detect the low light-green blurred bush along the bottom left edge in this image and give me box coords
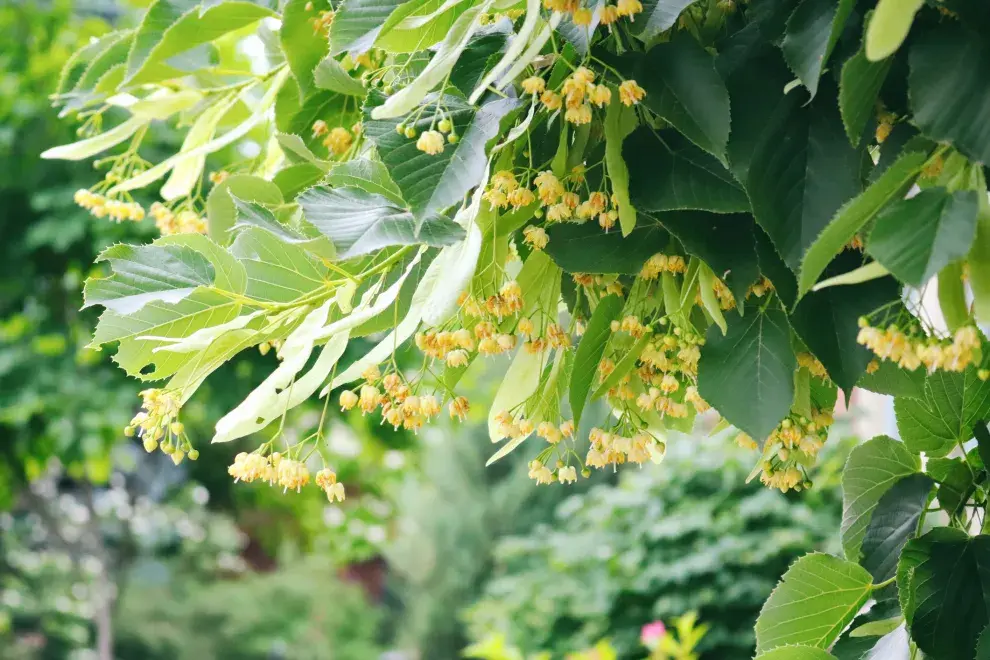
[116,558,382,660]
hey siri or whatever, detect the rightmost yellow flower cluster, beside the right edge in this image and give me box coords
[856,318,982,371]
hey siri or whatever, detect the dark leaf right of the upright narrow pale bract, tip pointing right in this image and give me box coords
[622,131,749,213]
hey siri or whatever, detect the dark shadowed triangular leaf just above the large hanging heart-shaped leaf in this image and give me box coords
[657,211,773,302]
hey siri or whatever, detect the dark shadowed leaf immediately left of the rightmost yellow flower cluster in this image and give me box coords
[790,251,901,397]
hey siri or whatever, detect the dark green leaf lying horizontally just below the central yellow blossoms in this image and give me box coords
[544,222,670,275]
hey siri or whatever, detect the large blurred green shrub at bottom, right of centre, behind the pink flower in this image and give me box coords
[464,430,842,660]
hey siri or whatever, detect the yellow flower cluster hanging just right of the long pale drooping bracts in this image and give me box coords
[340,367,450,431]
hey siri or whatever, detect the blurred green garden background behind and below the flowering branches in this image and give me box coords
[0,0,845,660]
